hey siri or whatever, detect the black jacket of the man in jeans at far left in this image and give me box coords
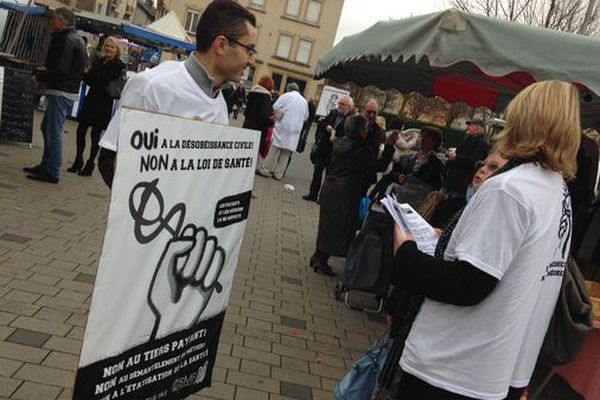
[35,27,87,93]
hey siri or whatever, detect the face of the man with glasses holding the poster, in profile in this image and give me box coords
[218,21,256,82]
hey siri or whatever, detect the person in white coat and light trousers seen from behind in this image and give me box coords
[257,83,308,180]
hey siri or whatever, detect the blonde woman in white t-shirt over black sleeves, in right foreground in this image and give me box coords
[392,81,581,400]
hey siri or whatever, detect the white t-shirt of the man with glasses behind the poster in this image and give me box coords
[100,61,229,151]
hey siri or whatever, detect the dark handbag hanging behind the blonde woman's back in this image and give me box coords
[538,257,594,367]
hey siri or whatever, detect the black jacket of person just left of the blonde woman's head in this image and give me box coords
[443,135,490,194]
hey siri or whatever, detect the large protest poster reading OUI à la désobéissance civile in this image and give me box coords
[73,110,259,400]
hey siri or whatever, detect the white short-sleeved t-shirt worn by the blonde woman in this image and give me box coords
[400,164,571,400]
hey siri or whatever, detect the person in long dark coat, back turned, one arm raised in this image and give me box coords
[310,115,398,276]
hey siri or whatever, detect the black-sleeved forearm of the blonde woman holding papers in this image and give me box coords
[392,241,498,306]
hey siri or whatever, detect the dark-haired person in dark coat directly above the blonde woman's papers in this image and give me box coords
[369,126,444,203]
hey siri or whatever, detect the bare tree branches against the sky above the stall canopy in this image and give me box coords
[450,0,600,36]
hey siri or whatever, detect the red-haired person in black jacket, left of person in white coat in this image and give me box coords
[243,75,275,159]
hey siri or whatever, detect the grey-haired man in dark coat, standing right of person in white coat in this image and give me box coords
[302,96,354,201]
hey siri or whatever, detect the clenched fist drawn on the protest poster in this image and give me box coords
[148,224,226,339]
